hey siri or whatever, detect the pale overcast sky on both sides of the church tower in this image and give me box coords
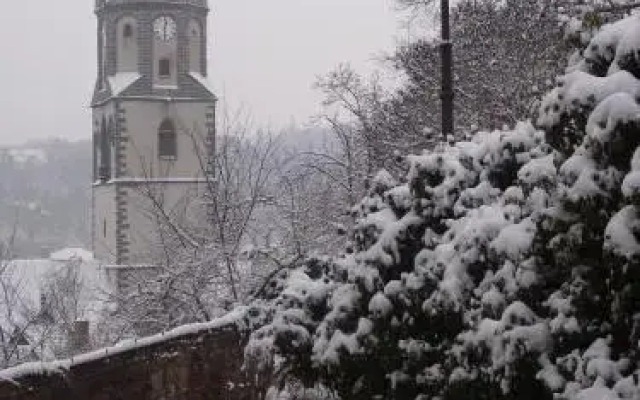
[0,0,410,145]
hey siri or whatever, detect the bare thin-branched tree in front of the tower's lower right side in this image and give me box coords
[99,107,286,339]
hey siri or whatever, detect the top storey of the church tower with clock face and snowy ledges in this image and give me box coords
[92,0,215,106]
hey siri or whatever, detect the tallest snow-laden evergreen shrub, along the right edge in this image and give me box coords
[537,11,640,399]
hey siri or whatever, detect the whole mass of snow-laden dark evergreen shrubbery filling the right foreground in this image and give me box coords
[246,10,640,400]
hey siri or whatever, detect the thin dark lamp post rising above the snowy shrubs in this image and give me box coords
[440,0,453,141]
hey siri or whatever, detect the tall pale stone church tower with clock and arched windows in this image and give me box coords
[91,0,216,266]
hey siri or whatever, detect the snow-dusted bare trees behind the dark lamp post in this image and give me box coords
[316,0,637,167]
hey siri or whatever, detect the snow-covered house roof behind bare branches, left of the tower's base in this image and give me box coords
[0,248,113,367]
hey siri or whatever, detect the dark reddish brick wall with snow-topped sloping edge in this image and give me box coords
[0,325,264,400]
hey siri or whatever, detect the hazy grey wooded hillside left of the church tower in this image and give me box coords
[0,139,92,258]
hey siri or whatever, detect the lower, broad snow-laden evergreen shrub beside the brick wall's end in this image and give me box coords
[247,123,556,399]
